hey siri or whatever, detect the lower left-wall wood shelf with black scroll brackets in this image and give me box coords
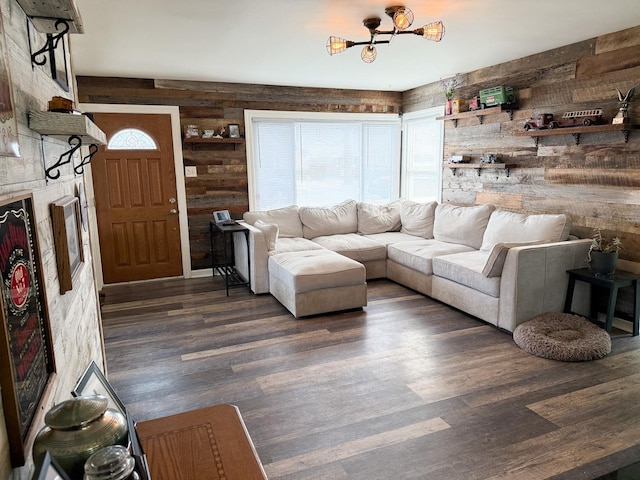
[29,112,107,180]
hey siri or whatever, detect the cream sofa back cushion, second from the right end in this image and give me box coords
[433,204,495,249]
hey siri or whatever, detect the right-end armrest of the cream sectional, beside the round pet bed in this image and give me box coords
[497,238,591,332]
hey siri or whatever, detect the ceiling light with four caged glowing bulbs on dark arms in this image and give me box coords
[327,6,444,63]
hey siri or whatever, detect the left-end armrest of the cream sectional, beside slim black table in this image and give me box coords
[234,222,269,293]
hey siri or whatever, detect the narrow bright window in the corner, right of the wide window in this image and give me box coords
[402,107,444,202]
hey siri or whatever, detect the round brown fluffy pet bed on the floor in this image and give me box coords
[513,312,611,362]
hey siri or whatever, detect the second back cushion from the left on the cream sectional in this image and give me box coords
[298,200,358,239]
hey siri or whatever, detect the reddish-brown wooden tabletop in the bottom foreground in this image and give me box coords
[136,405,267,480]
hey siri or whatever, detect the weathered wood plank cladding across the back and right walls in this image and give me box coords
[77,26,640,269]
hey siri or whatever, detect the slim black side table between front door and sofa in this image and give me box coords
[209,220,251,297]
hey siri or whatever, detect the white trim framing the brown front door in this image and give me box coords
[79,103,192,289]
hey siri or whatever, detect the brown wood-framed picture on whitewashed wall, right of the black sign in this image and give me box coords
[51,196,84,294]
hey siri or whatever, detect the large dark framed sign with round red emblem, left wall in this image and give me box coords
[0,193,55,467]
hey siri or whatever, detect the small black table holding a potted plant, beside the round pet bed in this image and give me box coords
[564,268,640,336]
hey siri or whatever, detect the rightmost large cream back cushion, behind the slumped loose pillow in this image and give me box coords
[480,210,571,251]
